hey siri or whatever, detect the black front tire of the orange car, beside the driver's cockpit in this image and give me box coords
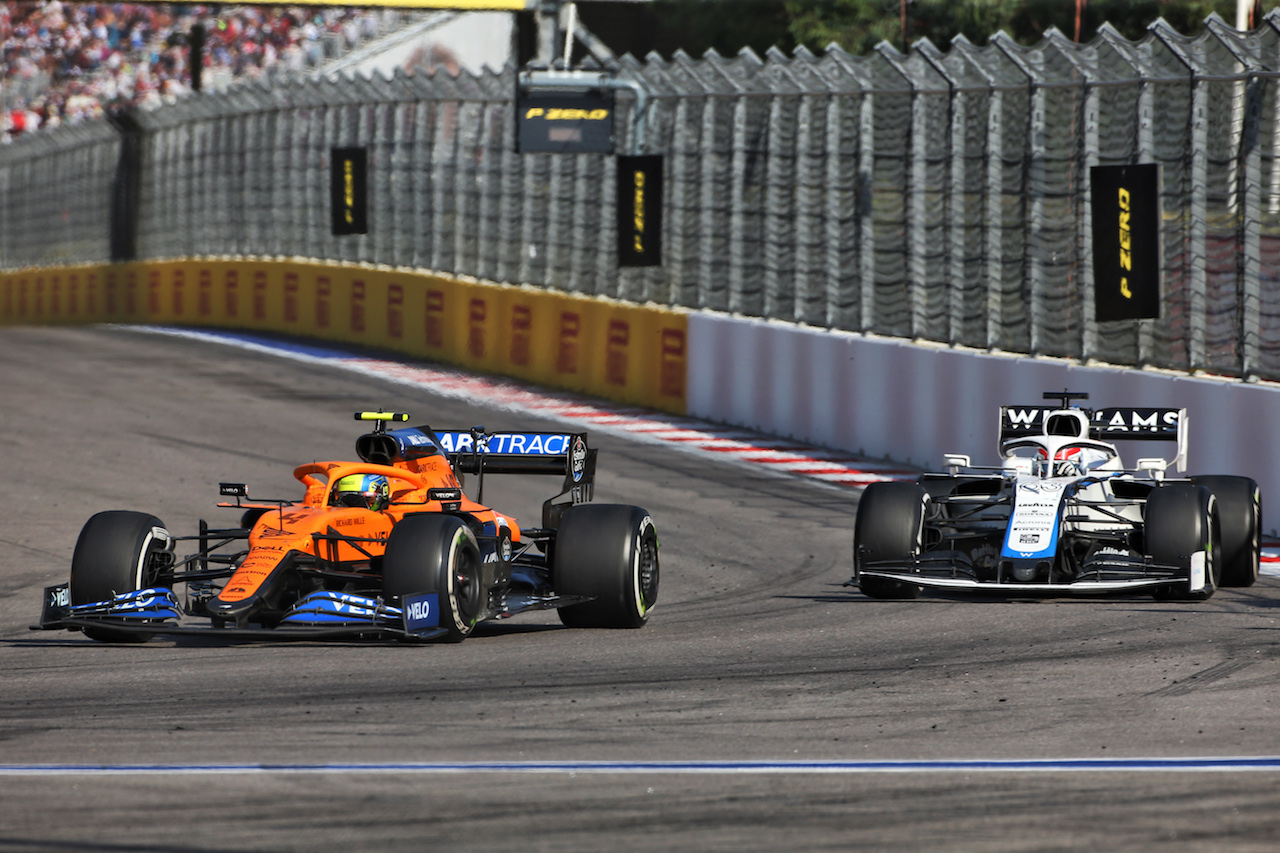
[383,515,489,643]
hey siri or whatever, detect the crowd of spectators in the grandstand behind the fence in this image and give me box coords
[0,0,394,142]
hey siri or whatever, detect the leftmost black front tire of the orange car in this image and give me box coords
[70,510,165,643]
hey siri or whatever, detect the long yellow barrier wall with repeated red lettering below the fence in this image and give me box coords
[0,259,689,414]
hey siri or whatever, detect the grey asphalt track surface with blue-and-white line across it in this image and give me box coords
[0,322,1280,853]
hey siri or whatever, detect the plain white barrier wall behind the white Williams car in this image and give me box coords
[687,311,1280,534]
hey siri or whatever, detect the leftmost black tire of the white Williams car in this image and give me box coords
[854,483,929,599]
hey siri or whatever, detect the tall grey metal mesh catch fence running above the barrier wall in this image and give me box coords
[0,13,1280,379]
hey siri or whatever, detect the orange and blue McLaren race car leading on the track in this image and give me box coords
[35,412,658,642]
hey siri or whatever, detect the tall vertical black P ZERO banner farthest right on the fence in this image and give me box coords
[1089,163,1160,323]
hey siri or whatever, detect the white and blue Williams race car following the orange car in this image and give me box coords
[850,392,1262,601]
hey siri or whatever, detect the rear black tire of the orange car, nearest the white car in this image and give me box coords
[552,503,658,628]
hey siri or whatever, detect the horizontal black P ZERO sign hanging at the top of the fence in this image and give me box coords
[516,90,613,154]
